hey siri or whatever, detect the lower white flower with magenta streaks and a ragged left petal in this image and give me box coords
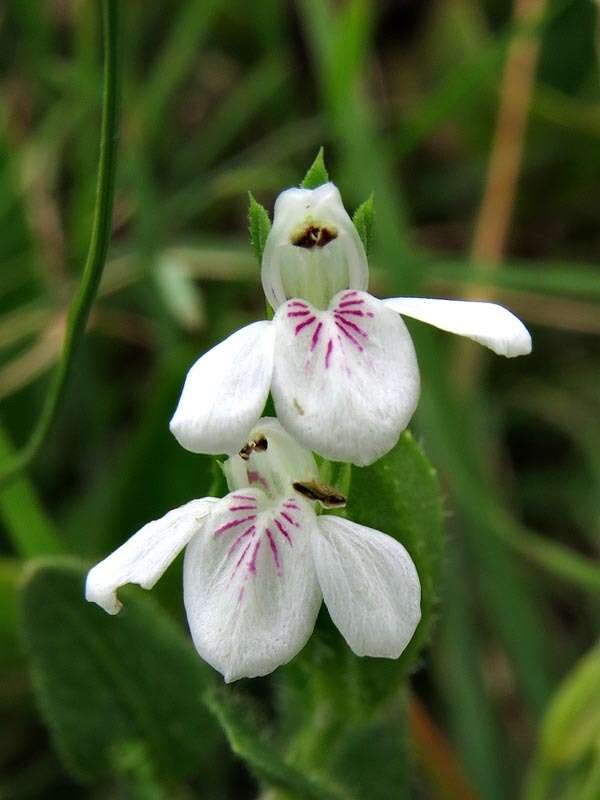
[86,418,421,681]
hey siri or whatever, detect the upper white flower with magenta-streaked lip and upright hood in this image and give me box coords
[171,183,531,465]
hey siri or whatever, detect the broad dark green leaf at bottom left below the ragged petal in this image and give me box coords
[22,559,224,781]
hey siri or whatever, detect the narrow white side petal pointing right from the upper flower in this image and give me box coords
[383,297,531,358]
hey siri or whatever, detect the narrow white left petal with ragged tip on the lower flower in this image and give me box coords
[85,497,218,614]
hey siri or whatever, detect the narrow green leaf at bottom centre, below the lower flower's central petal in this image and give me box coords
[205,689,345,800]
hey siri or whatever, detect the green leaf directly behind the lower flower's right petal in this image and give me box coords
[346,431,443,685]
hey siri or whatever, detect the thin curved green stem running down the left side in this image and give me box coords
[0,0,120,488]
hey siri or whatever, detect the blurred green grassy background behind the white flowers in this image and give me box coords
[0,0,600,800]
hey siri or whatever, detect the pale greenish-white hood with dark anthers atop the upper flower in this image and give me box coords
[262,183,369,309]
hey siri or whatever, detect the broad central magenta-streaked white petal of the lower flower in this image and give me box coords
[184,489,321,682]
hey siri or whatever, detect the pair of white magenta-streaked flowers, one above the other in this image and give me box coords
[86,177,531,681]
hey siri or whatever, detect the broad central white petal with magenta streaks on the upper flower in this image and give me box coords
[272,290,419,465]
